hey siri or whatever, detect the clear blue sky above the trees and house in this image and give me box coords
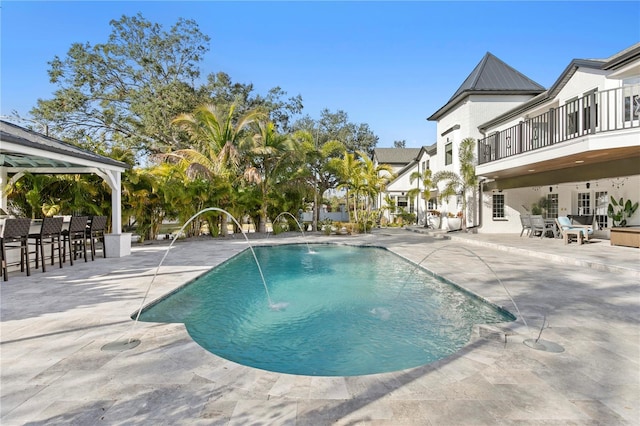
[0,0,640,147]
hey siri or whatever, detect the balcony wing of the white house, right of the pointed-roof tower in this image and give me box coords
[476,43,640,238]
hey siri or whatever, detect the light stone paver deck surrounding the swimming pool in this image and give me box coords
[0,229,640,425]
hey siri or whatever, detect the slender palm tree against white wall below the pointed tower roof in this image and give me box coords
[433,138,478,230]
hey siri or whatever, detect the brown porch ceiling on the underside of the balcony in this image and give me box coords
[485,146,640,189]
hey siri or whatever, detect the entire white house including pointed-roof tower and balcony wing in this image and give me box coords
[374,43,640,238]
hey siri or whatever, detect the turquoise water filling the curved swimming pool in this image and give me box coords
[140,244,514,376]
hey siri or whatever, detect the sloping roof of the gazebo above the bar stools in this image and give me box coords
[0,120,131,173]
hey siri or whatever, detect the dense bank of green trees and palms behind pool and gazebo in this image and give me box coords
[11,14,384,238]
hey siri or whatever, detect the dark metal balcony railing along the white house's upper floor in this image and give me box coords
[478,85,640,164]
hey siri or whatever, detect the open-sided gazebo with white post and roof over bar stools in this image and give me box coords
[0,120,131,257]
